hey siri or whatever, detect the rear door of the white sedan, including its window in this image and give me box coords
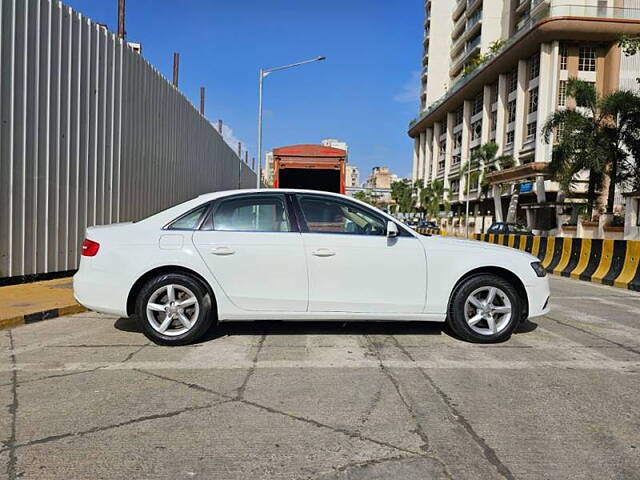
[193,194,308,312]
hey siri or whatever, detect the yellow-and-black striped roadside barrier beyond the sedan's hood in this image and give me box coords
[475,233,640,291]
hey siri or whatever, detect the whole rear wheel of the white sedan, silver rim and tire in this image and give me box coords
[136,273,214,345]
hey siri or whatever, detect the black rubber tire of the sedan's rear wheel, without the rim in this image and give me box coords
[135,273,216,346]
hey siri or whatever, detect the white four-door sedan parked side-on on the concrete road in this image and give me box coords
[73,189,549,345]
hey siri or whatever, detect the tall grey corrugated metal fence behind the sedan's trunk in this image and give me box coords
[0,0,256,279]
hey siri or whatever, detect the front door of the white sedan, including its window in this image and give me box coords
[296,194,427,313]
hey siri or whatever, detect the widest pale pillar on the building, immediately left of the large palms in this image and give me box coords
[534,41,560,162]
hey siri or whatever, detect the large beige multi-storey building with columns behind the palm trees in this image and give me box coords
[409,0,640,229]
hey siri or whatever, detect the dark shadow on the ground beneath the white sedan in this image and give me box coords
[114,317,538,344]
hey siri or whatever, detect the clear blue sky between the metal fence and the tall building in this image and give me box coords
[65,0,424,177]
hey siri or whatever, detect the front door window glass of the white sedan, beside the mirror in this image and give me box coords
[298,195,386,235]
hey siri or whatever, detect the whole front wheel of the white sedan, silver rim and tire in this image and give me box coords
[447,274,523,343]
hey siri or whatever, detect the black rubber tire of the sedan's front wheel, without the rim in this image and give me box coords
[447,274,524,343]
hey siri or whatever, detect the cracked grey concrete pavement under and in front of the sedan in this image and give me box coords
[0,277,640,479]
